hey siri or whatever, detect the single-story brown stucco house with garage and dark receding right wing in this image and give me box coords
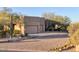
[15,16,66,34]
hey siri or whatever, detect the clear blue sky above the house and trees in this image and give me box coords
[0,7,79,22]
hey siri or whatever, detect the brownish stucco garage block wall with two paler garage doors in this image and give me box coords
[24,16,45,33]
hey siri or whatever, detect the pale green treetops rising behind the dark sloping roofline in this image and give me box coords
[42,12,71,24]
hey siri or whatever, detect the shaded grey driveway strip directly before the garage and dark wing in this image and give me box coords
[28,33,68,39]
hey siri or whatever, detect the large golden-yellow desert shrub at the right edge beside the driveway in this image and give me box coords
[68,23,79,45]
